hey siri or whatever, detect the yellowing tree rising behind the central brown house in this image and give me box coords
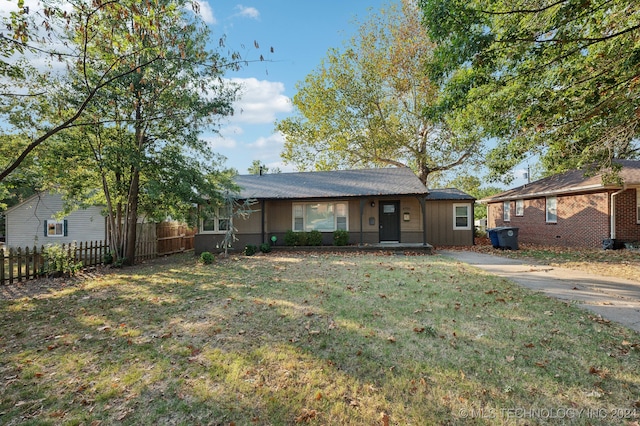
[276,0,479,183]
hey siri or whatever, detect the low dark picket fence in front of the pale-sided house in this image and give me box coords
[0,241,109,285]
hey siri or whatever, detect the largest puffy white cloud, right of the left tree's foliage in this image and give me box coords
[230,78,293,124]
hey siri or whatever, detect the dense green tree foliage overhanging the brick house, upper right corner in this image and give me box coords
[420,0,640,178]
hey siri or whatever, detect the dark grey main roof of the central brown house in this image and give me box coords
[235,168,428,200]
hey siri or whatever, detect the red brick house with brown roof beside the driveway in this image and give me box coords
[480,160,640,248]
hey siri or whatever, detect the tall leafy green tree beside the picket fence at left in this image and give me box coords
[0,0,260,262]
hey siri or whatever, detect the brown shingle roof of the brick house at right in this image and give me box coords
[480,160,640,203]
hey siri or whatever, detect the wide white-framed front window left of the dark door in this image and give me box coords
[293,203,349,232]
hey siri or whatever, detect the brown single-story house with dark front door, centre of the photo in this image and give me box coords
[194,168,475,254]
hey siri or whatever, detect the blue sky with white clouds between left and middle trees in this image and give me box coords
[201,0,384,174]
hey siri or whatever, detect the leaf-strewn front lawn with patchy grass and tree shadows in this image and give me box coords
[0,253,640,425]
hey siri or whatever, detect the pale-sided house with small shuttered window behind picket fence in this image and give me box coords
[5,192,107,248]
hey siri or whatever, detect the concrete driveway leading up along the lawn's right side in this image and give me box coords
[436,250,640,333]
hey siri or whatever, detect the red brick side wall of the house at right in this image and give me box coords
[487,192,610,248]
